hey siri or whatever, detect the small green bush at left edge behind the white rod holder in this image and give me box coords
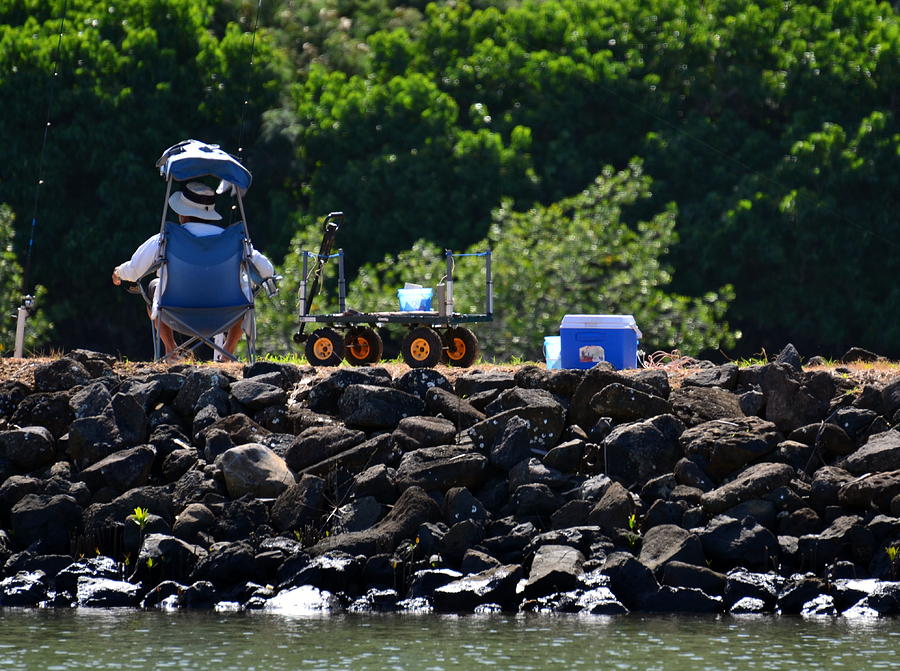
[0,205,53,356]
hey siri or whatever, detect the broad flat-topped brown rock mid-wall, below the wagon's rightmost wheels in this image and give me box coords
[397,445,488,492]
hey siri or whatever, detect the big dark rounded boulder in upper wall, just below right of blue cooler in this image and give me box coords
[602,415,684,483]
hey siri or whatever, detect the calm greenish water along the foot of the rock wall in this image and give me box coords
[0,610,900,671]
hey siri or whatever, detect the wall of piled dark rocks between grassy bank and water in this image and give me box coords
[0,347,900,617]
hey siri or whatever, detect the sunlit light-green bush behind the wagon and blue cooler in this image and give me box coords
[280,162,737,360]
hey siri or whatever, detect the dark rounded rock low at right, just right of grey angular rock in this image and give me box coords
[700,515,780,569]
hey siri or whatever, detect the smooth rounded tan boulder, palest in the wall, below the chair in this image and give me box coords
[216,443,294,499]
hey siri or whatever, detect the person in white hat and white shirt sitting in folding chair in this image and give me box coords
[112,182,275,356]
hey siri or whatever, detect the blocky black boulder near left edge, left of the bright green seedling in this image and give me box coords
[10,494,81,554]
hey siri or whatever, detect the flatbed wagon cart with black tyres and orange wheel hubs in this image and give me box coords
[294,212,494,368]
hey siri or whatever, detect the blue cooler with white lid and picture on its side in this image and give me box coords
[559,315,641,370]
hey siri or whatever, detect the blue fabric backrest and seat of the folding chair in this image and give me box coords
[159,222,253,338]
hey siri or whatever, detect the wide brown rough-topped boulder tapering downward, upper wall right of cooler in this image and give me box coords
[680,417,781,479]
